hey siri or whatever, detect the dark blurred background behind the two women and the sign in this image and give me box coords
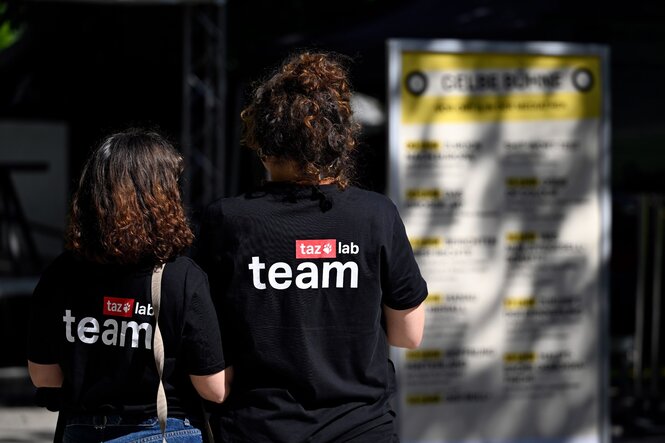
[0,0,665,441]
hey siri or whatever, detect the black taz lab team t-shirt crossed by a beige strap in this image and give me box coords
[28,253,224,417]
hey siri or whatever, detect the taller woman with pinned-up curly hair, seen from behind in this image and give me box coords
[196,52,427,443]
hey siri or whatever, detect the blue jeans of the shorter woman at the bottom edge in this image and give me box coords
[62,415,203,443]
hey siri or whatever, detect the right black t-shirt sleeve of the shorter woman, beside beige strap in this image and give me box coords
[183,271,226,375]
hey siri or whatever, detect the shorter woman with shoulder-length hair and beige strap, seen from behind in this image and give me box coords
[28,129,228,442]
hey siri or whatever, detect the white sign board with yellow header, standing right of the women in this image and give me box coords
[388,40,610,443]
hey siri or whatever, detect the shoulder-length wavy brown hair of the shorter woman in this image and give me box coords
[65,128,194,264]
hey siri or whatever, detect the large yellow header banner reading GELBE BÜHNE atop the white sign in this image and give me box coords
[401,52,602,124]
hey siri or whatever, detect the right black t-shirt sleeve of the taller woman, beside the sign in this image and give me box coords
[381,205,427,310]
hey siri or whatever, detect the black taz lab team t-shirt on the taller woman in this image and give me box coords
[196,183,427,443]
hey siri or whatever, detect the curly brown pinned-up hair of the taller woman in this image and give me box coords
[240,51,360,187]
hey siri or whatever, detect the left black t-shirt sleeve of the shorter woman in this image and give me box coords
[27,267,62,365]
